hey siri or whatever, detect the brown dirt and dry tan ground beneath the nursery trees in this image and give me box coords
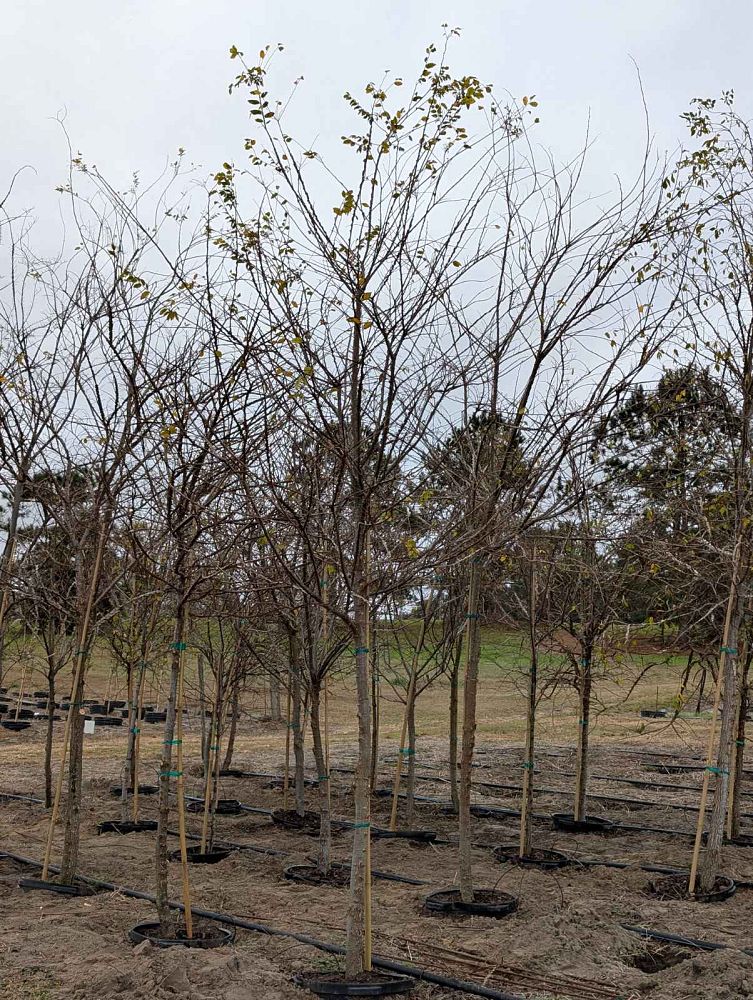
[0,660,753,1000]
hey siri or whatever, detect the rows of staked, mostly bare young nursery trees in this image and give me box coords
[0,39,753,972]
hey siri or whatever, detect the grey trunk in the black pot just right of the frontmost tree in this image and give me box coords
[459,562,481,903]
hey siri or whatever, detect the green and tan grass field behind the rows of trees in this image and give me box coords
[4,626,707,760]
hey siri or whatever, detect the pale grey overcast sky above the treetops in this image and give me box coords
[0,0,753,237]
